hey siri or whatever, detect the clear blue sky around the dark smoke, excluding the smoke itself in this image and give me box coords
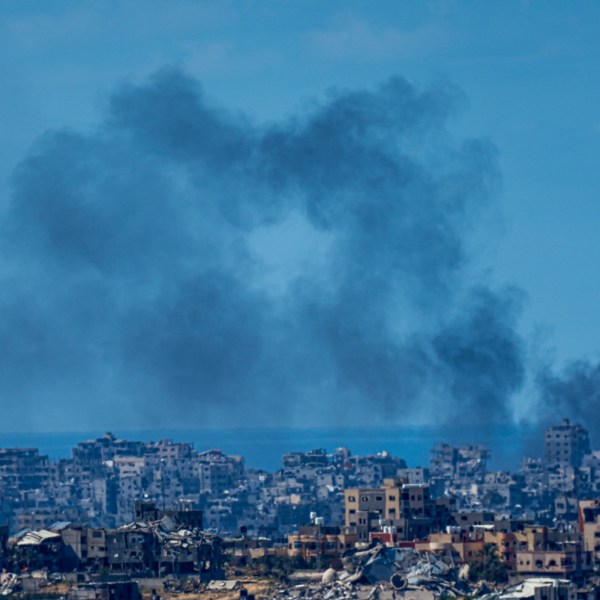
[0,0,600,428]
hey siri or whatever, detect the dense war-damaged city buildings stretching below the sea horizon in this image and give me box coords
[0,419,600,598]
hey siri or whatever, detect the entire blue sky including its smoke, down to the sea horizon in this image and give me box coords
[0,0,600,430]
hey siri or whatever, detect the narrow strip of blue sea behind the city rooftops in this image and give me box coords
[0,424,542,471]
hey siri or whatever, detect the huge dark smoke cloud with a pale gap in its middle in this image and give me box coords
[0,70,525,428]
